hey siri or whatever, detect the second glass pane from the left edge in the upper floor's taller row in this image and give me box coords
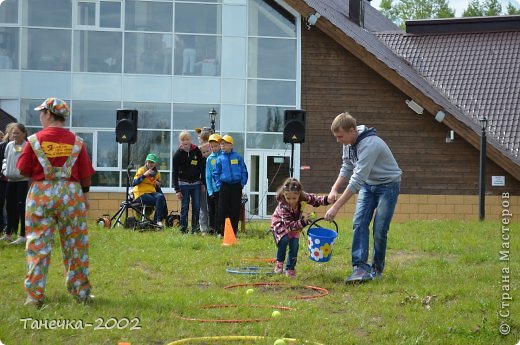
[22,29,71,71]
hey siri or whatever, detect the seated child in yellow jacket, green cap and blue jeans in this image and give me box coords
[132,153,166,227]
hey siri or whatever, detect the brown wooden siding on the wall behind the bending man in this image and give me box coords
[301,28,520,195]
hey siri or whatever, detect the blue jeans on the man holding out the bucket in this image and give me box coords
[352,182,401,273]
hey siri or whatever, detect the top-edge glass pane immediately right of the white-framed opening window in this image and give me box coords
[125,0,173,32]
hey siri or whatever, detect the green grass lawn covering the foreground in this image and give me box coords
[0,221,520,345]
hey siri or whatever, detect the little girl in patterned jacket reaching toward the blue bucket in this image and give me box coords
[271,177,329,277]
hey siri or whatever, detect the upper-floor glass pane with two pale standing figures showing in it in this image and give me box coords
[175,35,221,76]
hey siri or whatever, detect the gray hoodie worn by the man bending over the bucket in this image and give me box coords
[339,125,402,193]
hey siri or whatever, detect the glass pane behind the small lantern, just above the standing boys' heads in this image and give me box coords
[173,104,220,131]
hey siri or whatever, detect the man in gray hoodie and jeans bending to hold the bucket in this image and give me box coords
[325,112,401,283]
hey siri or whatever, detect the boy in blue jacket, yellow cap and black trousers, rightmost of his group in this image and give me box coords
[213,135,248,235]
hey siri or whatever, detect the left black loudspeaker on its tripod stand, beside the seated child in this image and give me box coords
[113,109,138,226]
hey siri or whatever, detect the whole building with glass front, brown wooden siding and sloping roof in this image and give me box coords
[0,0,520,221]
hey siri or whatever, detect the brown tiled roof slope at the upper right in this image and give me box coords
[378,31,520,162]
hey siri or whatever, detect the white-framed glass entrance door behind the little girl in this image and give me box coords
[246,150,291,219]
